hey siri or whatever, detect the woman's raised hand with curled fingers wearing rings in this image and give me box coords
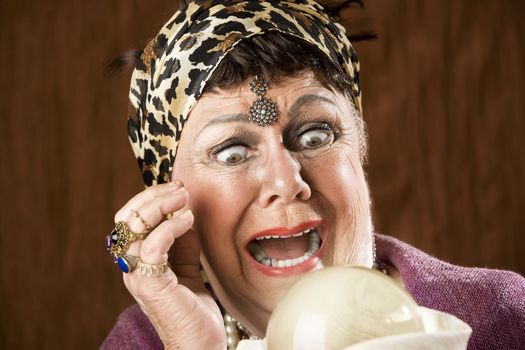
[115,182,226,350]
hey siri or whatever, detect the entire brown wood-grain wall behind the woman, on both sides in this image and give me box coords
[0,0,525,349]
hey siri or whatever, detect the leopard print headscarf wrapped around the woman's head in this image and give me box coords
[128,0,361,186]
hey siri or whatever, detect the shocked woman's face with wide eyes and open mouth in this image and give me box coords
[173,73,373,336]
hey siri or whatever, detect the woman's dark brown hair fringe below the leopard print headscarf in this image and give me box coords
[203,31,367,161]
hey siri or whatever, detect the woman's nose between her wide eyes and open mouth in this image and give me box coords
[255,143,312,208]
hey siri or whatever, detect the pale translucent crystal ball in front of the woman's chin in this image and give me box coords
[266,266,424,350]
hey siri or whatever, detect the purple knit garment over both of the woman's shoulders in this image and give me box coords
[101,234,525,350]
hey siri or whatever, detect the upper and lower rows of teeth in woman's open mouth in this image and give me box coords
[248,229,321,268]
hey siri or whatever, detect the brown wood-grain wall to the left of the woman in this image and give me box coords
[0,0,173,349]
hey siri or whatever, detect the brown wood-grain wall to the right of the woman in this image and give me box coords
[357,0,525,273]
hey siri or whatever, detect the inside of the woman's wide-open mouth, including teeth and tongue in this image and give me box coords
[247,225,323,268]
